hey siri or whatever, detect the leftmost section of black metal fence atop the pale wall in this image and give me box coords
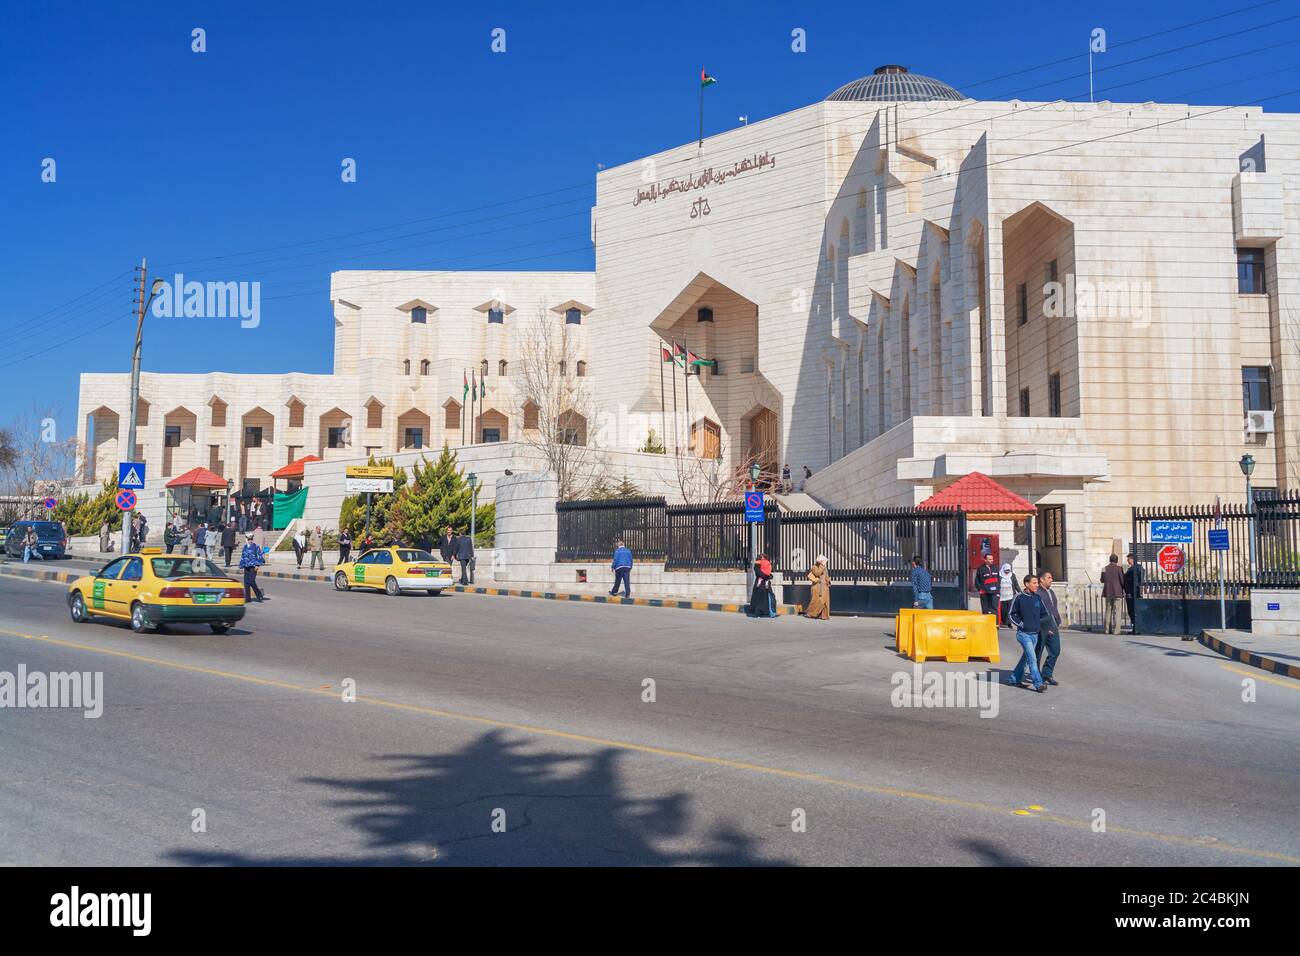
[555,498,668,561]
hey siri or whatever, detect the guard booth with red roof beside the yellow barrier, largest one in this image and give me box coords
[917,471,1037,607]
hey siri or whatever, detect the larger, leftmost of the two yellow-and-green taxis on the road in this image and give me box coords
[68,548,244,633]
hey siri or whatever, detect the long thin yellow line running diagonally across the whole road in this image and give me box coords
[0,628,1300,864]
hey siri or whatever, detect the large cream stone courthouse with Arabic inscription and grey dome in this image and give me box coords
[79,66,1300,579]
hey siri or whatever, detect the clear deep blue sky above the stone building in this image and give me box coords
[0,0,1300,434]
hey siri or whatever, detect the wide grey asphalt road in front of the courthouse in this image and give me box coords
[0,564,1300,866]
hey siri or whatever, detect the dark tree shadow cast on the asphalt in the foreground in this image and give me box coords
[168,730,789,866]
